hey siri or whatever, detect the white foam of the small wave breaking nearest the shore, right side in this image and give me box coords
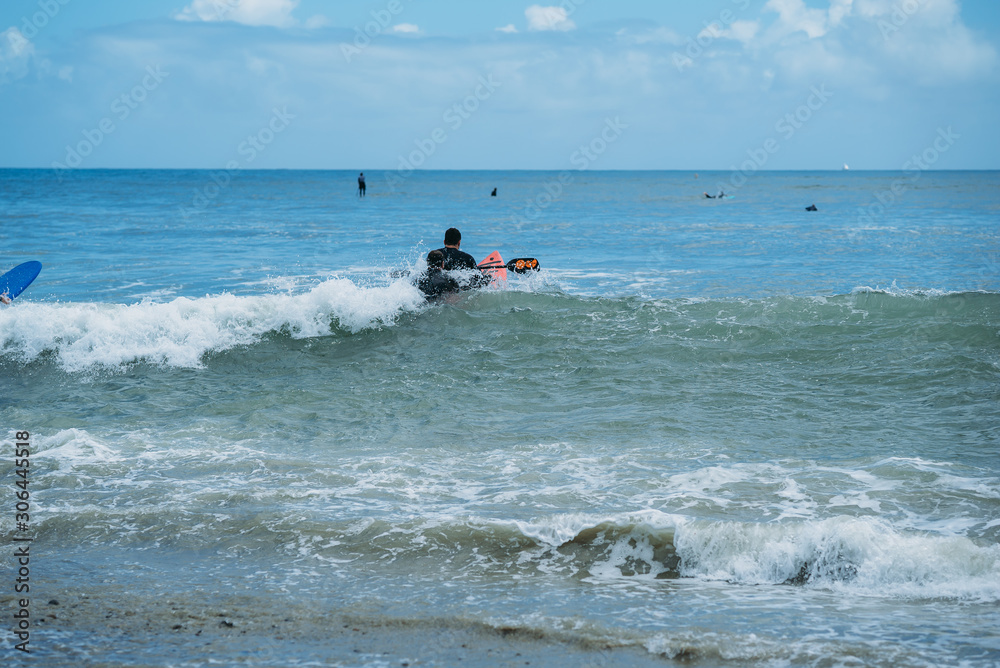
[674,517,1000,602]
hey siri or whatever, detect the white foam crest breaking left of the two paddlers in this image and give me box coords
[0,278,424,372]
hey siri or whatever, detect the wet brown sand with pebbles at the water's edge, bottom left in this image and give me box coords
[2,591,680,667]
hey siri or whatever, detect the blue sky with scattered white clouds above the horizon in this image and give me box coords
[0,0,1000,170]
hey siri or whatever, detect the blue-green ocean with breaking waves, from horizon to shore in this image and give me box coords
[0,169,1000,668]
